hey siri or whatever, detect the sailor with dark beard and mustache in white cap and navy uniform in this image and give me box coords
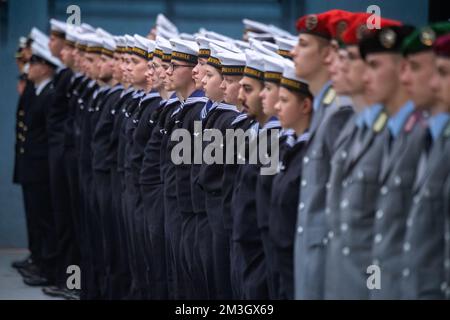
[231,50,280,299]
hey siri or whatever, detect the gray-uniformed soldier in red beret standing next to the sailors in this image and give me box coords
[292,12,353,299]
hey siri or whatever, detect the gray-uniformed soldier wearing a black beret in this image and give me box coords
[359,26,423,299]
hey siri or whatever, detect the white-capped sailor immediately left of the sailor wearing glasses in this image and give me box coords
[139,36,178,300]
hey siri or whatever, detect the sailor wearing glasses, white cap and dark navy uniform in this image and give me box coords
[161,39,208,298]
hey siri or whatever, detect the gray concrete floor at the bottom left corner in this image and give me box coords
[0,249,62,300]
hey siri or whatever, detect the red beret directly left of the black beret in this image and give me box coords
[341,12,402,45]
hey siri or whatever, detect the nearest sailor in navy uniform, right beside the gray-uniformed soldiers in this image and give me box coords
[268,63,313,299]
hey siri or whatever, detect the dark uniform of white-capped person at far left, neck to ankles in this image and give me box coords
[16,82,58,283]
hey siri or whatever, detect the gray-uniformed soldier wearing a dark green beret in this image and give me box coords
[400,28,450,299]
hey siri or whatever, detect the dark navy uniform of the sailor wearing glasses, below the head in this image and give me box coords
[175,97,215,299]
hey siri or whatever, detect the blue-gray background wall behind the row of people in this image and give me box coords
[0,0,428,247]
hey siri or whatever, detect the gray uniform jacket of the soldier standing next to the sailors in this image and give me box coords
[294,88,353,299]
